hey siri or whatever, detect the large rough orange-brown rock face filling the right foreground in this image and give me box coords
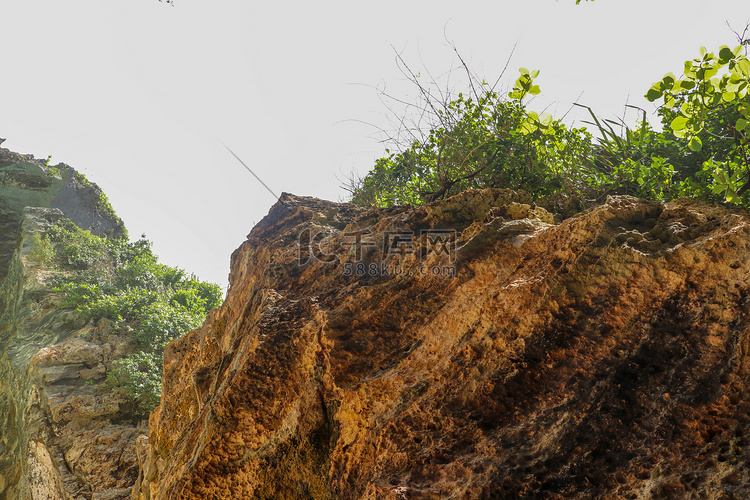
[133,190,750,500]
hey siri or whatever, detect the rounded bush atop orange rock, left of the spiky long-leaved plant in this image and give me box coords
[353,68,598,206]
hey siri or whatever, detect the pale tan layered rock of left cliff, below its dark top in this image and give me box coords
[0,208,145,500]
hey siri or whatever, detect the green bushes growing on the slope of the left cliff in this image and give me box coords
[49,223,222,417]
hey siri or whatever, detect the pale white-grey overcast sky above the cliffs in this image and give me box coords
[0,0,750,286]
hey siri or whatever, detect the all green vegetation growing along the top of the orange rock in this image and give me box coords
[349,36,750,209]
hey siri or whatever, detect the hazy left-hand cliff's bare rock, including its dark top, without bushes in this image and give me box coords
[0,148,139,500]
